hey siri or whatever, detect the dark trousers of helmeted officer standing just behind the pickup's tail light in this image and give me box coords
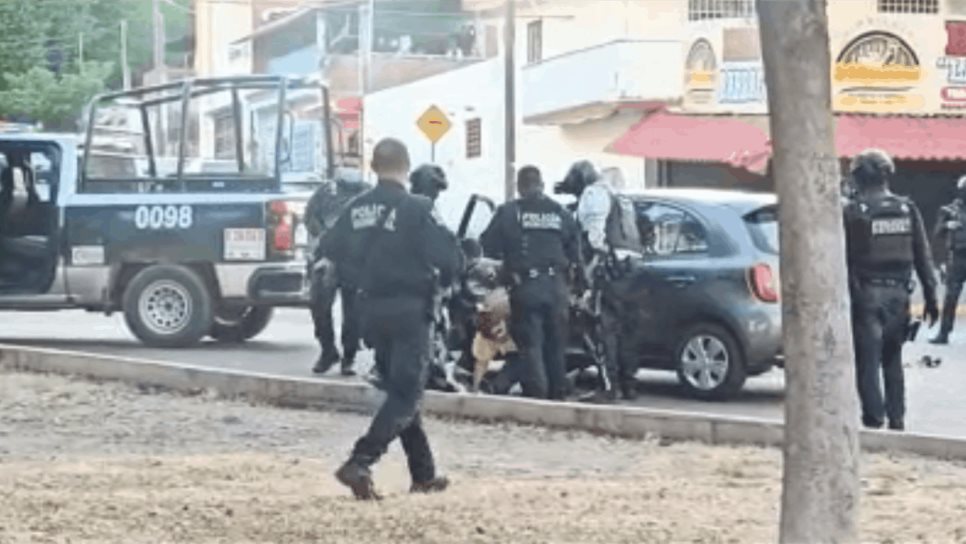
[309,273,360,360]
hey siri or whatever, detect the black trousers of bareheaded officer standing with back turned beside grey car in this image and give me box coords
[510,271,570,399]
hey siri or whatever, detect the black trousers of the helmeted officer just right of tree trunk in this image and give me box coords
[852,282,910,427]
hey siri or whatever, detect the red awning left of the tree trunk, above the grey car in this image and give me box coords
[609,111,771,173]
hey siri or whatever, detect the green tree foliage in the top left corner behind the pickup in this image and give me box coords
[0,0,192,129]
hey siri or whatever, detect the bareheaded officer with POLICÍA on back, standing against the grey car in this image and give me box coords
[480,166,580,399]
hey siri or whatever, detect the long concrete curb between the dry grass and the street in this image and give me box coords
[0,345,966,459]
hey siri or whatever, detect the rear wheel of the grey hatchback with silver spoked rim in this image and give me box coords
[674,323,747,400]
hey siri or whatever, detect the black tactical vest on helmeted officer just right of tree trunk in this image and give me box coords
[855,195,914,272]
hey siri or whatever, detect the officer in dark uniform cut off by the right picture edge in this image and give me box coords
[930,176,966,344]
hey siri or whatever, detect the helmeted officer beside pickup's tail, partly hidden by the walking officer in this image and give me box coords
[305,173,372,376]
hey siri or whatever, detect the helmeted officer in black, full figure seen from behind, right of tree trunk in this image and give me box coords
[845,149,939,431]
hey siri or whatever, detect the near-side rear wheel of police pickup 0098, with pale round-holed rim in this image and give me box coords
[122,265,214,348]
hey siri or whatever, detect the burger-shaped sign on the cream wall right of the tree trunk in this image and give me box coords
[832,31,925,112]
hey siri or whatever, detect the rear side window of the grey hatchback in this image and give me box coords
[636,202,708,257]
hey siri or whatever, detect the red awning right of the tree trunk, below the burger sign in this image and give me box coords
[835,115,966,161]
